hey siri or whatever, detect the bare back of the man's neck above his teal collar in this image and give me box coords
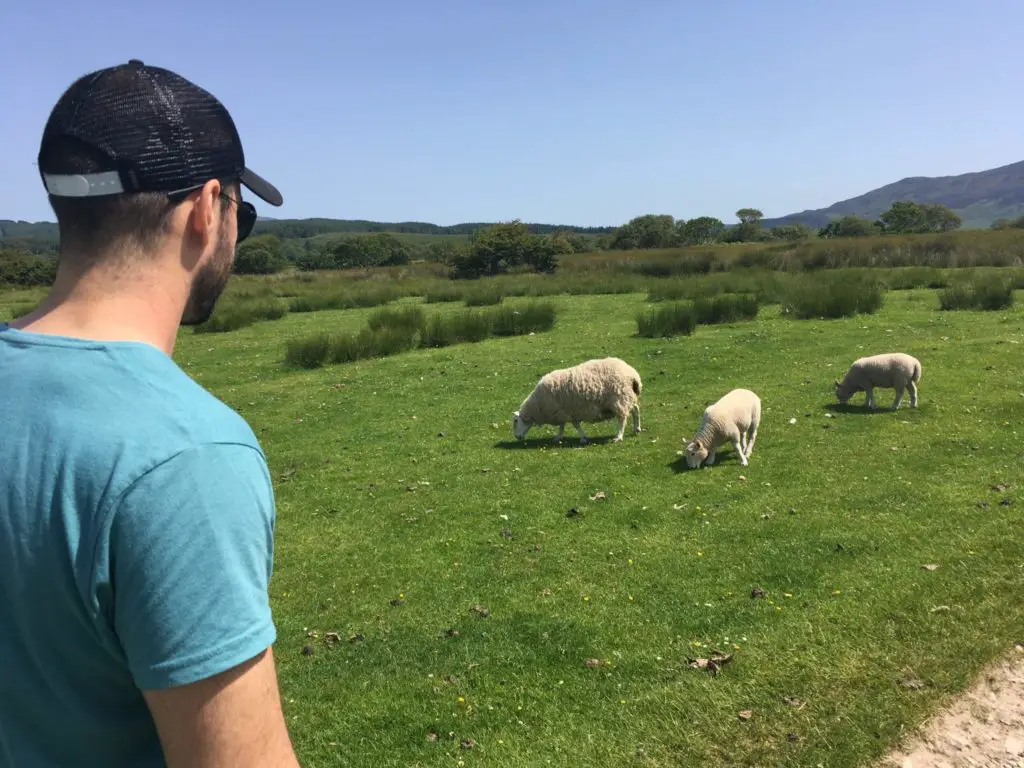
[10,262,184,355]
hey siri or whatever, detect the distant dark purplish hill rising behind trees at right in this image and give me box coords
[763,161,1024,228]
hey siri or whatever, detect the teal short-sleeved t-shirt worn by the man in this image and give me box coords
[0,324,276,768]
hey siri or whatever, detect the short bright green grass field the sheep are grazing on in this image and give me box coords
[0,282,1024,768]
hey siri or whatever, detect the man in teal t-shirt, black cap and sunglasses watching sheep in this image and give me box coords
[0,60,298,768]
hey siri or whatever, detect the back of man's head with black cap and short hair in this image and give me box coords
[39,59,283,261]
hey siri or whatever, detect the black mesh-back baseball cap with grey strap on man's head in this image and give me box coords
[38,59,284,206]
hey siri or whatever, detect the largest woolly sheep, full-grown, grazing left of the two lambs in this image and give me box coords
[512,357,643,444]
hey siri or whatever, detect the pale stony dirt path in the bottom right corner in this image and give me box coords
[879,643,1024,768]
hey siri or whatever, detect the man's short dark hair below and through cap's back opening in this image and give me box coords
[47,138,237,261]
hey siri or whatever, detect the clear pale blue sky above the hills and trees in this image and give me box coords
[0,0,1024,225]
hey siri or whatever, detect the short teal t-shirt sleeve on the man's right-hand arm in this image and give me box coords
[110,443,276,689]
